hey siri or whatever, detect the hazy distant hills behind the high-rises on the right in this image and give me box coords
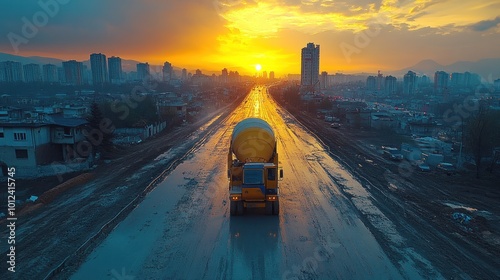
[388,58,500,79]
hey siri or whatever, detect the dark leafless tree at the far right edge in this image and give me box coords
[464,105,500,179]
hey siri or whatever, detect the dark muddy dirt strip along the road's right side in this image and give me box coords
[280,103,500,279]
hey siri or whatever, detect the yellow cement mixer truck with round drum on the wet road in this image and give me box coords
[227,118,283,215]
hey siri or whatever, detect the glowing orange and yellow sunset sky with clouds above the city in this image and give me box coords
[0,0,500,77]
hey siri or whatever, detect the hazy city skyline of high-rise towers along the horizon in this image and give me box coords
[0,53,494,86]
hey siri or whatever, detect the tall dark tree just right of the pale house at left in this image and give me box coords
[86,102,113,157]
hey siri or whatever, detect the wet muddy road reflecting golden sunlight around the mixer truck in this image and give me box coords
[72,87,441,279]
